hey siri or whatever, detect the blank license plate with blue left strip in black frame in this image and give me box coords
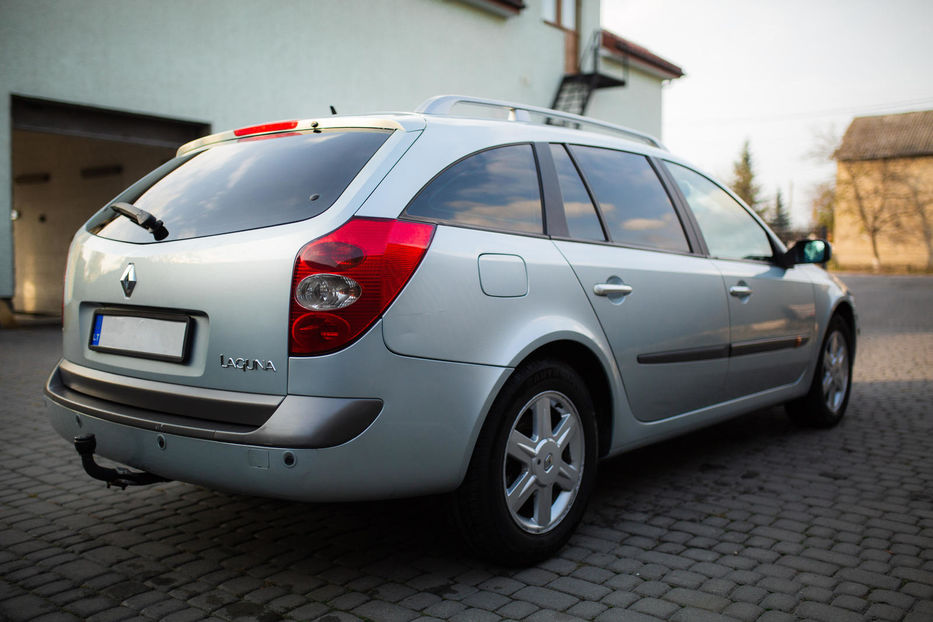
[88,311,191,363]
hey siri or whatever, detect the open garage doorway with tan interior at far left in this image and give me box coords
[12,97,210,316]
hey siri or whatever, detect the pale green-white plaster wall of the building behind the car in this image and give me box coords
[0,0,660,298]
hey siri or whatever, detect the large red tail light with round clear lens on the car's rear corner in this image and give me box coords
[288,218,434,356]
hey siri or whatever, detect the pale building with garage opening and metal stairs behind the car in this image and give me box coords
[0,0,682,320]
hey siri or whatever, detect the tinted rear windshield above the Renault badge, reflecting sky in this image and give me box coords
[91,129,391,243]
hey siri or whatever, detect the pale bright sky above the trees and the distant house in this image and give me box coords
[601,0,933,226]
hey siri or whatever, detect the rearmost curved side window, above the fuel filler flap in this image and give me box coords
[405,145,544,233]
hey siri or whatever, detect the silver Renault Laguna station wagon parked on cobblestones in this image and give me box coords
[45,96,857,564]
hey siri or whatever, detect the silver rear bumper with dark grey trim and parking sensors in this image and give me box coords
[46,330,510,501]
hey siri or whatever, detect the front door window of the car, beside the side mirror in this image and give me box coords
[665,162,774,261]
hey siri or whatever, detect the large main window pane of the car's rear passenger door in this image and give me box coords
[570,145,690,252]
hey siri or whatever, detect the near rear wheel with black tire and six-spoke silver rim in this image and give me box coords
[451,360,597,566]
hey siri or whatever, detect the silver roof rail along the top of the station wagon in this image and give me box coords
[415,95,667,151]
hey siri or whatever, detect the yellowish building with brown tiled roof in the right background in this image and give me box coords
[833,110,933,271]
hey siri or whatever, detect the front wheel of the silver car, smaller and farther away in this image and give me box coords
[785,315,854,428]
